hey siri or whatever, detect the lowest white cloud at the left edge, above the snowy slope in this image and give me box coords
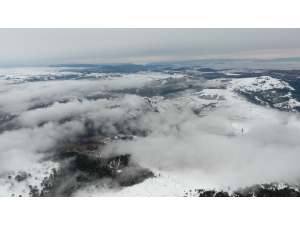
[0,121,85,173]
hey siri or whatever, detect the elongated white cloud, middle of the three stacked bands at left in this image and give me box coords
[17,95,146,129]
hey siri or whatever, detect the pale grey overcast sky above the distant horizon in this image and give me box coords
[0,29,300,66]
